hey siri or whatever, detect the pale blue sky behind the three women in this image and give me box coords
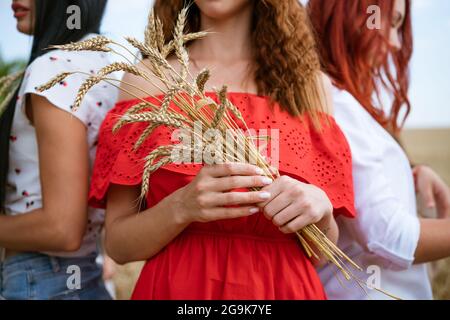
[0,0,450,128]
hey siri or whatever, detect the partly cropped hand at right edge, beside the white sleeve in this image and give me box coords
[413,166,450,219]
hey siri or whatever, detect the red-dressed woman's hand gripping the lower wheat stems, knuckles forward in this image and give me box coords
[258,176,333,234]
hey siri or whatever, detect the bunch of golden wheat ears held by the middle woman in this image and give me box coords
[37,8,400,295]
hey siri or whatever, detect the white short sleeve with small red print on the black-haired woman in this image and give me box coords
[22,50,99,126]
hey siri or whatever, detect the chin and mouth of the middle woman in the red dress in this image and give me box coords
[195,0,252,20]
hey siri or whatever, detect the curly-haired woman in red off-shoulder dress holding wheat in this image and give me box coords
[90,0,354,300]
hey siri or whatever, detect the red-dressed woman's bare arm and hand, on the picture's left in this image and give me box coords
[106,163,270,264]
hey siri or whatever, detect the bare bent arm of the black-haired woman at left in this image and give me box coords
[0,95,89,251]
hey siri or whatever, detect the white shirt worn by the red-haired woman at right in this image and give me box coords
[319,88,433,300]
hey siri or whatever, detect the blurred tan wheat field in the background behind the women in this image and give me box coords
[110,129,450,300]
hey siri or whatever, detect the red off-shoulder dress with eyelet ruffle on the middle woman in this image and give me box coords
[90,93,355,300]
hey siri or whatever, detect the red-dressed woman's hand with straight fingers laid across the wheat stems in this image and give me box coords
[172,163,273,223]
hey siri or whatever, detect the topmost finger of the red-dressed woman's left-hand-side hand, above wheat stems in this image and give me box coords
[210,176,273,191]
